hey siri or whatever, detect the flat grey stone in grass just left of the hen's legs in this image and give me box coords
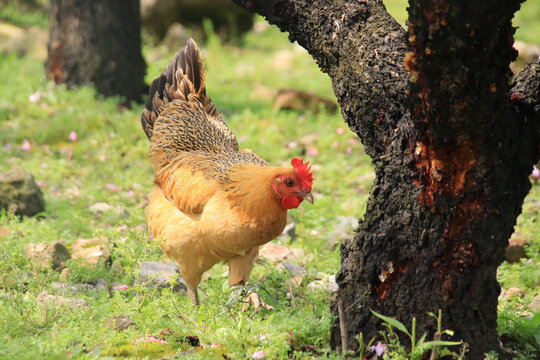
[140,261,187,292]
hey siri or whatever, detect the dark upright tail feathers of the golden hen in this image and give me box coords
[141,38,217,139]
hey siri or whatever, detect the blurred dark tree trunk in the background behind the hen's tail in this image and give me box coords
[46,0,146,101]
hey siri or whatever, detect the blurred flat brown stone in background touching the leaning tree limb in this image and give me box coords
[274,89,337,114]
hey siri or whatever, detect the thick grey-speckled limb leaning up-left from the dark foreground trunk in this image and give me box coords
[232,0,407,161]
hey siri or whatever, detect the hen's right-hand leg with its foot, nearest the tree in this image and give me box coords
[229,247,274,311]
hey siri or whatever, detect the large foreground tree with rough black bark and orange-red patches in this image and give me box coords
[233,0,540,359]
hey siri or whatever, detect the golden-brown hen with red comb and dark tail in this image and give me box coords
[141,39,313,305]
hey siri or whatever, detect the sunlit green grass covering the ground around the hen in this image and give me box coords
[0,1,540,359]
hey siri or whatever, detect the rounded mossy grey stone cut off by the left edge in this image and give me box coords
[0,168,45,216]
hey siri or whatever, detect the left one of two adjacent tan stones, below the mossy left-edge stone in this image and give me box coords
[24,241,71,269]
